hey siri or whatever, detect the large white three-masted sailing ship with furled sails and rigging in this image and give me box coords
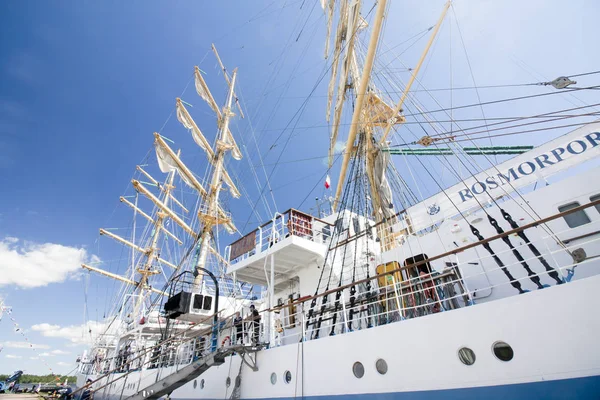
[78,0,600,400]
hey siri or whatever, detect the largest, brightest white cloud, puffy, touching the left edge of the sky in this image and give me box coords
[0,237,98,288]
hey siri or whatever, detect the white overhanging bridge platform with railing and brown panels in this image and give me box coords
[226,209,334,288]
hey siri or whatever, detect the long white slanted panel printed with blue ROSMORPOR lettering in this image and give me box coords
[400,122,600,231]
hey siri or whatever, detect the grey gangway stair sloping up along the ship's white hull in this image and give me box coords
[125,345,262,400]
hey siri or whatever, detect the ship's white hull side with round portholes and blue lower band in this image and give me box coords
[89,276,600,400]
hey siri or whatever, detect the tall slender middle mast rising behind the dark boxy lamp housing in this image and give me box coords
[194,68,237,287]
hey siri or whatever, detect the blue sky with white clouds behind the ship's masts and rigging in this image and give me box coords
[0,0,600,373]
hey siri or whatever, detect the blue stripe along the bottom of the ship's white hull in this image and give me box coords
[178,376,600,400]
